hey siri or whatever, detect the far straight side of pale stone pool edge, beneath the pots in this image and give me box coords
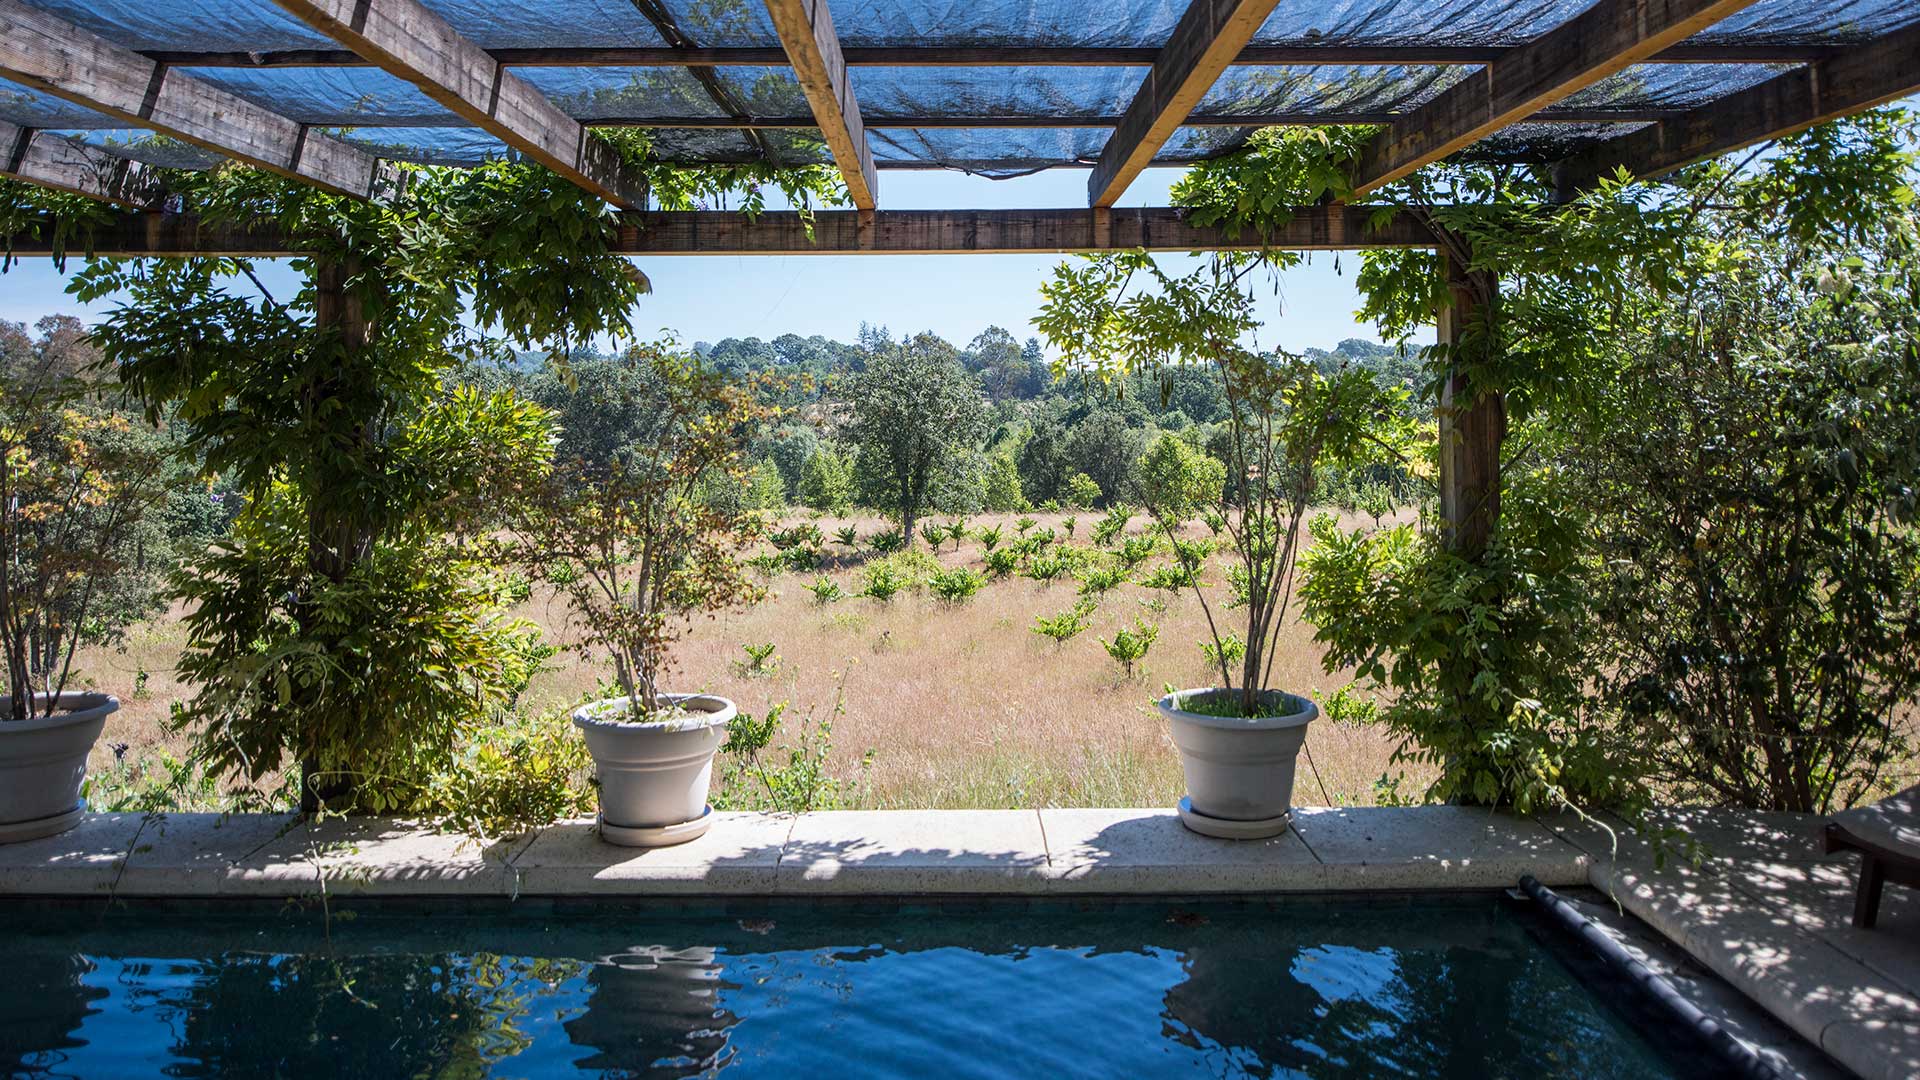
[0,807,1590,899]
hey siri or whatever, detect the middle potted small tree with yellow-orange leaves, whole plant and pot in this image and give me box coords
[520,342,770,847]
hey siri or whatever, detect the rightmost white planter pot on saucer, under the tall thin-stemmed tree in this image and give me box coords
[1160,690,1319,840]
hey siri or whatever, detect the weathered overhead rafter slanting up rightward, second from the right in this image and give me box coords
[1354,0,1753,198]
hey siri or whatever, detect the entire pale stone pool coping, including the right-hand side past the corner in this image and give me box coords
[0,807,1920,1078]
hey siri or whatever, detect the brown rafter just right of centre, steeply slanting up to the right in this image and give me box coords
[1087,0,1277,208]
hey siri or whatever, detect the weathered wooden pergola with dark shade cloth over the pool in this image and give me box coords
[0,0,1920,550]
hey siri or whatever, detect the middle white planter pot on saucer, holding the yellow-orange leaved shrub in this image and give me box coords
[574,694,737,847]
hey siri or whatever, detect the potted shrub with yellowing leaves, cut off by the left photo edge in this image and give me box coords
[0,348,163,844]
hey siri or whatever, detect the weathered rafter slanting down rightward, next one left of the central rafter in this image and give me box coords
[276,0,647,209]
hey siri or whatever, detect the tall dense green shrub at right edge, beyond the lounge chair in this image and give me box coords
[1563,215,1920,813]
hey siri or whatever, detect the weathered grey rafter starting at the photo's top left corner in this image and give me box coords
[0,0,390,198]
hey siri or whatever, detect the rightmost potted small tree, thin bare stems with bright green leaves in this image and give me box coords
[1035,252,1394,840]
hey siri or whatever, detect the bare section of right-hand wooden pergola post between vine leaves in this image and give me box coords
[1434,256,1507,559]
